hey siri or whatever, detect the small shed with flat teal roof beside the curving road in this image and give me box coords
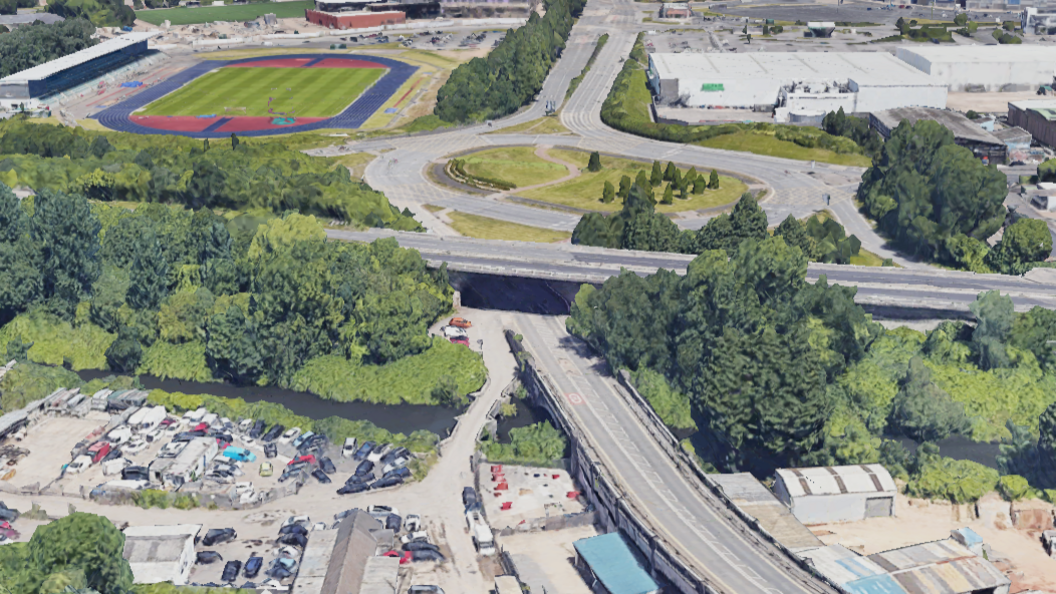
[572,532,660,594]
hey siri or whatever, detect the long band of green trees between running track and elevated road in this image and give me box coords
[0,120,420,229]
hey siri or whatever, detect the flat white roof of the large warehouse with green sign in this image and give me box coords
[649,48,941,87]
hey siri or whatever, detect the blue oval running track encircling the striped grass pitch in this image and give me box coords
[95,54,418,138]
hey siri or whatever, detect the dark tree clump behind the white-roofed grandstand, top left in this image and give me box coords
[0,19,97,77]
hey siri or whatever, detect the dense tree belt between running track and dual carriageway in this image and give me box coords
[433,0,586,122]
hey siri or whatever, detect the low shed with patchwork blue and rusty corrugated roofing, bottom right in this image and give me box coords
[797,531,1012,594]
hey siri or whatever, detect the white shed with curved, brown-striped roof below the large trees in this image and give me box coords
[774,464,898,525]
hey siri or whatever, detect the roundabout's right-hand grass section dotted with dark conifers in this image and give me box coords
[517,149,748,212]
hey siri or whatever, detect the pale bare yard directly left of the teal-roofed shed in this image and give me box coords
[502,526,598,594]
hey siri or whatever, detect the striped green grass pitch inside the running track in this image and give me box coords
[136,68,386,117]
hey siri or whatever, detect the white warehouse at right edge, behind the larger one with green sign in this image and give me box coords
[895,43,1056,93]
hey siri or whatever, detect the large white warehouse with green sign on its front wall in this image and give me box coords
[648,52,946,122]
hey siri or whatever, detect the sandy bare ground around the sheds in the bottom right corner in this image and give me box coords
[810,495,1056,594]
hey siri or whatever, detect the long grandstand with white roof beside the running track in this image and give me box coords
[0,32,161,108]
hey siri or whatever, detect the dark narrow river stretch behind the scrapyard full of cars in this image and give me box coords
[69,369,464,439]
